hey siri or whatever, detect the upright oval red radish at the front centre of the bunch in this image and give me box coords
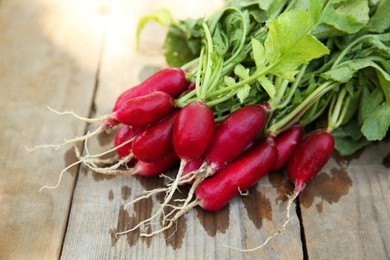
[173,101,214,161]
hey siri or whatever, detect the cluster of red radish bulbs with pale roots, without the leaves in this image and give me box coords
[51,65,334,248]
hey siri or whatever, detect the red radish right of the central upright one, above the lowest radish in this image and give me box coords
[205,105,267,172]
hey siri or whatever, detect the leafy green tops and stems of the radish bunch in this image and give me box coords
[137,0,390,155]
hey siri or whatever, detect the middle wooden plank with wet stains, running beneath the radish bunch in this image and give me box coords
[62,0,303,259]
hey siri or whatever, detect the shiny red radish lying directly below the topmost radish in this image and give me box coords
[113,91,175,127]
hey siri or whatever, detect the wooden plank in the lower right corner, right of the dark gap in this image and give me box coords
[300,142,390,259]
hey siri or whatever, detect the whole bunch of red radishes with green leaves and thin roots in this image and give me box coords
[34,0,390,249]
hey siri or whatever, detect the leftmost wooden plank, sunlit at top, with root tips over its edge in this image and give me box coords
[0,0,106,259]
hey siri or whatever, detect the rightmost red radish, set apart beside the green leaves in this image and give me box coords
[287,129,335,193]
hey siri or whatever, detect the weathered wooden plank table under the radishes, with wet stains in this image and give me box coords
[0,0,390,259]
